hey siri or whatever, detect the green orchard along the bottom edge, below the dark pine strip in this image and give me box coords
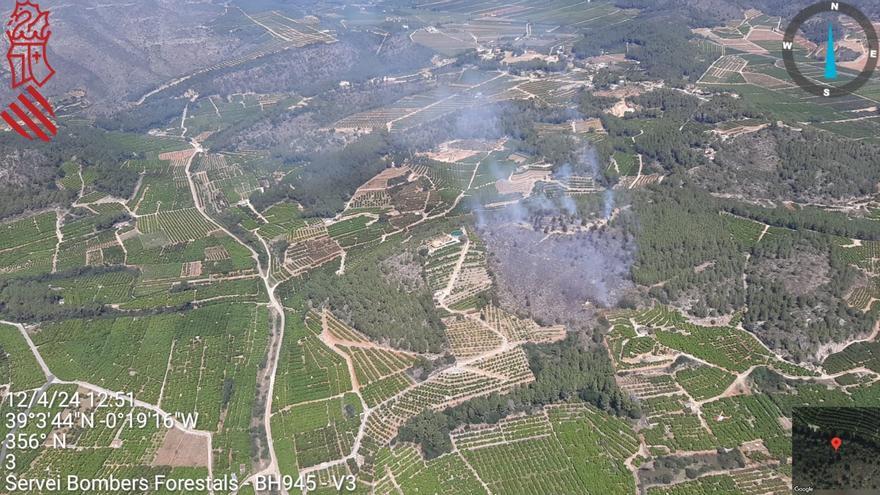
[376,406,637,494]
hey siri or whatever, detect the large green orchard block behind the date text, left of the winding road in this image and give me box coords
[3,305,268,482]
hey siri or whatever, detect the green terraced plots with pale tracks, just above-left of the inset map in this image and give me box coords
[606,306,828,480]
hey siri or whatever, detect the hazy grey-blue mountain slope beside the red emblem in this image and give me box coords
[0,0,254,112]
